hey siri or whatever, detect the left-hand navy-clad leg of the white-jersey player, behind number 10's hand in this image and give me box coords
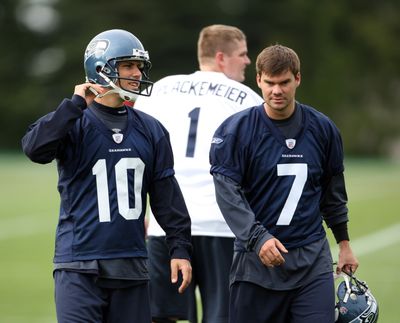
[147,236,195,319]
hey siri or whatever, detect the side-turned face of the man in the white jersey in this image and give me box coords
[223,40,251,82]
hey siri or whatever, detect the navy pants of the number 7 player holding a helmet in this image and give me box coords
[229,272,335,323]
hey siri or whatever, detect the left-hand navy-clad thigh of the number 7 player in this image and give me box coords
[229,282,290,323]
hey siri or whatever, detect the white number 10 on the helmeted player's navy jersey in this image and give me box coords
[92,158,145,222]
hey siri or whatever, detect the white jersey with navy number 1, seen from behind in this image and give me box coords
[134,71,263,237]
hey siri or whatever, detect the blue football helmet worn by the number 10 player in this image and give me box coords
[84,29,153,101]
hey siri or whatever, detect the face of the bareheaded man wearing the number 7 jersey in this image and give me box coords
[257,70,300,119]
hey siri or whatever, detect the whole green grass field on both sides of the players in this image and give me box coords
[0,154,400,323]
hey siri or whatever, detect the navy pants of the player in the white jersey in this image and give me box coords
[147,236,234,323]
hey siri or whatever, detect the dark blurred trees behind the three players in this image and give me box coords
[0,0,400,158]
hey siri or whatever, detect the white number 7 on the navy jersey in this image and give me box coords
[276,164,307,225]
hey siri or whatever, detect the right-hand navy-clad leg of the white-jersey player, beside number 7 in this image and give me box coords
[192,236,234,323]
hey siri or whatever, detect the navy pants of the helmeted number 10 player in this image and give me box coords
[54,270,151,323]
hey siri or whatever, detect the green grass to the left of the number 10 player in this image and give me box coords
[0,155,59,323]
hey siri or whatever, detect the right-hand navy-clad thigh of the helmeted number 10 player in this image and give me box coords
[107,282,151,323]
